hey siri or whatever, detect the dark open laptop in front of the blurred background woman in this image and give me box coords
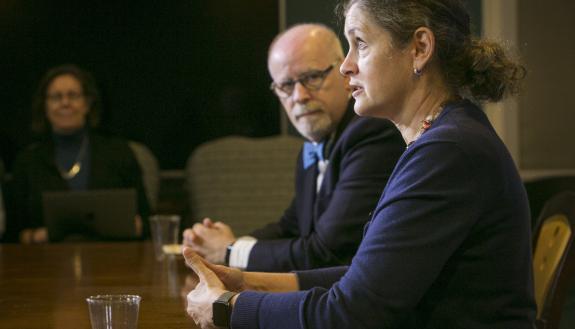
[42,189,137,241]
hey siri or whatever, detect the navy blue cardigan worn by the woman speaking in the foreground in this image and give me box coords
[231,101,536,329]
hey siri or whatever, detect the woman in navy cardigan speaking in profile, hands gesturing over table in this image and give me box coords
[184,0,536,329]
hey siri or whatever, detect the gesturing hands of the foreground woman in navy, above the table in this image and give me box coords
[183,247,230,329]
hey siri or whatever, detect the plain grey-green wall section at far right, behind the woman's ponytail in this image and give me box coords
[518,0,575,170]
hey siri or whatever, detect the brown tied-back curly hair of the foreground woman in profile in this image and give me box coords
[336,0,526,101]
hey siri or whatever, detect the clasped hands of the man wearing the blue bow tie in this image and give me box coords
[183,218,236,264]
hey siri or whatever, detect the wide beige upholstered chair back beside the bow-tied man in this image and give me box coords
[186,136,302,236]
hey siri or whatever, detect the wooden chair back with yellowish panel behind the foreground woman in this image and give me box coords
[533,192,575,329]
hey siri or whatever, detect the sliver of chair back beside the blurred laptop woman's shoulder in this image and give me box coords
[128,141,160,211]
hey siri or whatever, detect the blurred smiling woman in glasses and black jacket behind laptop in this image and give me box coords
[9,65,149,243]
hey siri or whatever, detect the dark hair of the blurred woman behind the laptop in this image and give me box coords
[32,64,101,134]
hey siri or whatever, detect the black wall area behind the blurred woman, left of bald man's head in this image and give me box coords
[0,0,279,169]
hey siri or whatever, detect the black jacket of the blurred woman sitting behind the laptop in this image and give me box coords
[7,133,149,238]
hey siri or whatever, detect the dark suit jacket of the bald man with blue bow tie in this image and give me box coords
[247,110,405,272]
